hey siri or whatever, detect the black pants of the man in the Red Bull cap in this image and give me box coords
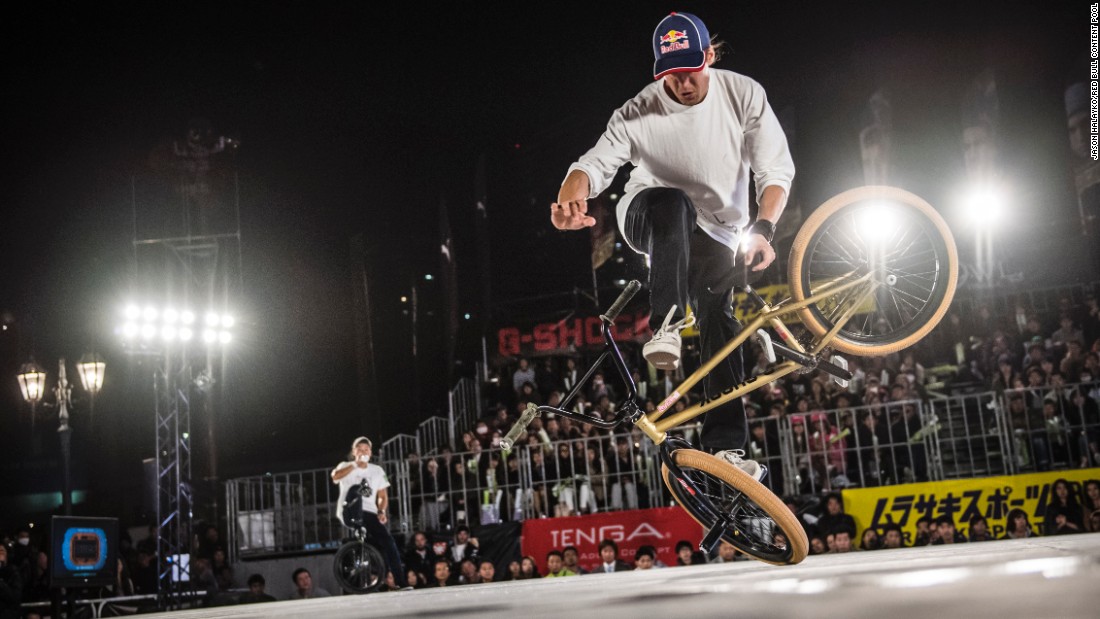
[626,188,748,453]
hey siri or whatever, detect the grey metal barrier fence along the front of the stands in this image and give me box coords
[227,383,1100,561]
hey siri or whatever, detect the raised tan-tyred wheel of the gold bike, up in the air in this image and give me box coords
[788,186,958,356]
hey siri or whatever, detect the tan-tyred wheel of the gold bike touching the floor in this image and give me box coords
[661,450,810,565]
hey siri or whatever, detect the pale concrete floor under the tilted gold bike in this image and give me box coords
[137,534,1100,619]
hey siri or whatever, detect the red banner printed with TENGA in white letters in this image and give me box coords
[523,507,703,574]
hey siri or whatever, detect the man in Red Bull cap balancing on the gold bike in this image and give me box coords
[550,13,794,479]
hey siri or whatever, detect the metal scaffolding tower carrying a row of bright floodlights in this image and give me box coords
[125,121,241,609]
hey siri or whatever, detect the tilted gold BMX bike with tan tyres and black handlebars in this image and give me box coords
[501,186,958,565]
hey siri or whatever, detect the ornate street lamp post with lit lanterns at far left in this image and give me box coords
[15,354,107,516]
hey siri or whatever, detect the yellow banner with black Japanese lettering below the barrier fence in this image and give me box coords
[842,468,1100,544]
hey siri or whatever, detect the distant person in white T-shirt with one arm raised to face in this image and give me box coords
[332,436,408,588]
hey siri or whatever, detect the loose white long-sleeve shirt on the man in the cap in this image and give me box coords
[569,69,794,252]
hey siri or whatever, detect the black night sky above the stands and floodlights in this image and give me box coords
[0,2,1088,523]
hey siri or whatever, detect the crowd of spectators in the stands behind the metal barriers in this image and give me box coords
[396,295,1100,538]
